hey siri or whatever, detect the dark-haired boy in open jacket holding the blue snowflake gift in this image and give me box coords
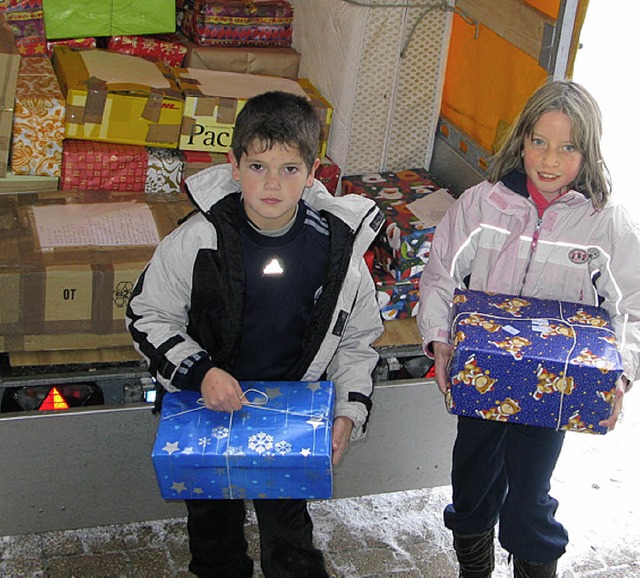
[127,92,383,578]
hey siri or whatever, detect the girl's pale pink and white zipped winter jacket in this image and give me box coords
[418,173,640,381]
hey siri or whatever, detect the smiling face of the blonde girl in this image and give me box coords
[523,110,583,201]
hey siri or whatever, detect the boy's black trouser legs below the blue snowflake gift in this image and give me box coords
[186,500,328,578]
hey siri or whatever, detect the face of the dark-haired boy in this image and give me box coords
[231,141,320,230]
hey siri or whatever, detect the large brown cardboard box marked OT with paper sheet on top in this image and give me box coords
[0,191,192,336]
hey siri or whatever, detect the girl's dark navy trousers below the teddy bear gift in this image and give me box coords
[444,416,568,563]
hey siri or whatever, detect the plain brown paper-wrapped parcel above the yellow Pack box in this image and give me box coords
[182,40,301,80]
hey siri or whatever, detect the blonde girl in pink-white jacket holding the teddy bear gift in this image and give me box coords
[418,81,640,578]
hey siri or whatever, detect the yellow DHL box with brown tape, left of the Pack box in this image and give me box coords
[53,46,184,148]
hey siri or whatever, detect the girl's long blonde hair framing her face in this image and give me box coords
[488,80,611,210]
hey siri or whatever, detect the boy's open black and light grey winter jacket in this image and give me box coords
[126,165,384,438]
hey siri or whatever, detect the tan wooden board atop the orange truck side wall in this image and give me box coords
[456,0,555,61]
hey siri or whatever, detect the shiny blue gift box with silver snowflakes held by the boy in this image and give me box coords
[152,381,335,500]
